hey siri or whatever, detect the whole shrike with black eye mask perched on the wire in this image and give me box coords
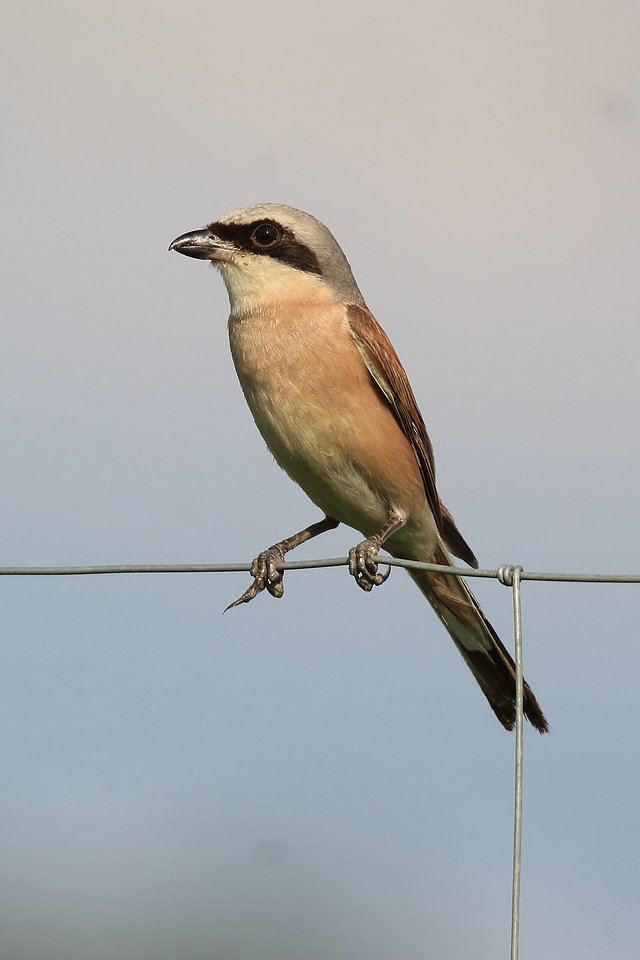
[169,203,548,733]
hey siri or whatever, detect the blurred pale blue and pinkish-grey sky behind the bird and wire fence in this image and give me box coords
[0,0,640,960]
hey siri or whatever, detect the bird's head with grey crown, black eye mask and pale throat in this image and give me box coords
[169,203,364,315]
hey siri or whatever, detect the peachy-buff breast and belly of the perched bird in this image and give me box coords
[229,306,437,555]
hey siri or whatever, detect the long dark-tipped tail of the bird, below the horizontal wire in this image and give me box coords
[407,548,549,733]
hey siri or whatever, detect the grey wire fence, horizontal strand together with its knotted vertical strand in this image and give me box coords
[0,554,640,960]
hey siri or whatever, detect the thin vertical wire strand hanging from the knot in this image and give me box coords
[511,567,524,960]
